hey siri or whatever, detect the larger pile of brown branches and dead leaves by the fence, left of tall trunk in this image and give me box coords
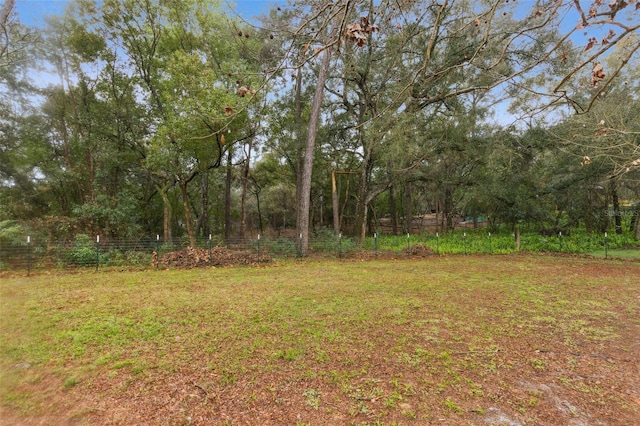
[158,247,271,268]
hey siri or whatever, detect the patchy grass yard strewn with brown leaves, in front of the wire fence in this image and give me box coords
[0,255,640,425]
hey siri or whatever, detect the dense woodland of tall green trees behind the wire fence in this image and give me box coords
[0,0,640,254]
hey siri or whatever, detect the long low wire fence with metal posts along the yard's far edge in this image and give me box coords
[0,228,628,274]
